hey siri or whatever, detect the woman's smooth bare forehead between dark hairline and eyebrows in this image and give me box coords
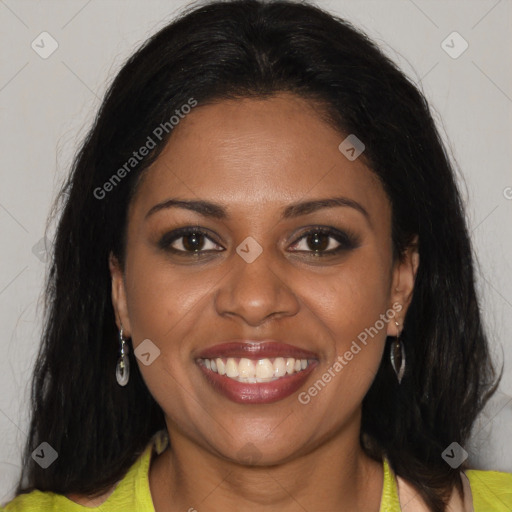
[128,94,389,224]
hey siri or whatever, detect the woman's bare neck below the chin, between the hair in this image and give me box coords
[150,420,383,512]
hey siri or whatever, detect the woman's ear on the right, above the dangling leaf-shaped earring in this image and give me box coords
[387,235,420,336]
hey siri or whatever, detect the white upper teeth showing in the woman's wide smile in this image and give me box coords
[200,357,308,383]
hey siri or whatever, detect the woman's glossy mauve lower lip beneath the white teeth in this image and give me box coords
[198,361,318,404]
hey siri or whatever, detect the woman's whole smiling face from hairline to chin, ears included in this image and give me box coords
[111,94,417,464]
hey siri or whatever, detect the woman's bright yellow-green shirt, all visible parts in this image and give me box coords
[2,431,512,512]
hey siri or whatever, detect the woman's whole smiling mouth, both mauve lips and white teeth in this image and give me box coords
[195,341,318,404]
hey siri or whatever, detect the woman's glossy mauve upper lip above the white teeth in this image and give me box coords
[197,339,318,359]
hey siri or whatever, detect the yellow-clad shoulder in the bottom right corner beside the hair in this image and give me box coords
[464,469,512,512]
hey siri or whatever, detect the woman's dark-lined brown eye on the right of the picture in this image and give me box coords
[291,226,359,256]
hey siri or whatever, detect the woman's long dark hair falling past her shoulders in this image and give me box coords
[17,0,496,511]
